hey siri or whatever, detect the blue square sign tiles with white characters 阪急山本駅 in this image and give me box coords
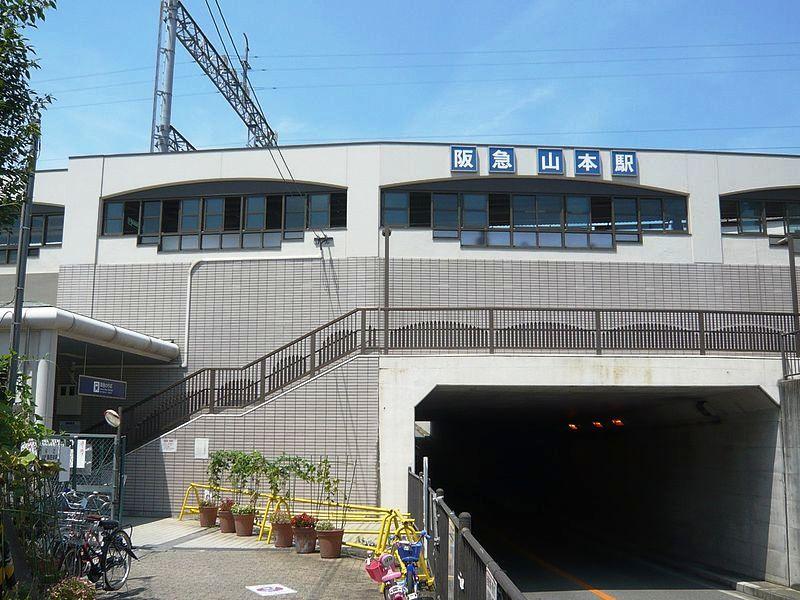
[450,146,639,177]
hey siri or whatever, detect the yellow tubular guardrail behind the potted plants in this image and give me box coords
[178,483,433,585]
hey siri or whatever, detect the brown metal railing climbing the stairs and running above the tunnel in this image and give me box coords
[112,307,795,451]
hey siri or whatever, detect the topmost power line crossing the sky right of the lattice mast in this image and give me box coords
[253,40,800,59]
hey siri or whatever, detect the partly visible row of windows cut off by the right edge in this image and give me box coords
[719,199,800,236]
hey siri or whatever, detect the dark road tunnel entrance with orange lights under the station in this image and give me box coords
[416,386,786,598]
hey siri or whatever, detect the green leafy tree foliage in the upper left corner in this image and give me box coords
[0,0,56,227]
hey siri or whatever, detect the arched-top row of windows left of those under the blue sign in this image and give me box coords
[103,193,347,251]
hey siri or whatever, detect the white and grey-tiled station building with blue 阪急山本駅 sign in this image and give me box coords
[12,142,800,583]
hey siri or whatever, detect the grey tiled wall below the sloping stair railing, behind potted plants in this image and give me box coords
[125,357,378,515]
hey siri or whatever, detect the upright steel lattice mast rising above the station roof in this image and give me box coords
[151,0,178,152]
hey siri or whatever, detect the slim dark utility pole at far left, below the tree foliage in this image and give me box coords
[7,132,39,399]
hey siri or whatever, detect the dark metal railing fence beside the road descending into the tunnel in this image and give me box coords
[408,471,525,600]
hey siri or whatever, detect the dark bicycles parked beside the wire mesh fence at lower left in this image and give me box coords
[59,491,138,590]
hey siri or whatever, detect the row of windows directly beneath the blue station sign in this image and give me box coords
[382,191,687,248]
